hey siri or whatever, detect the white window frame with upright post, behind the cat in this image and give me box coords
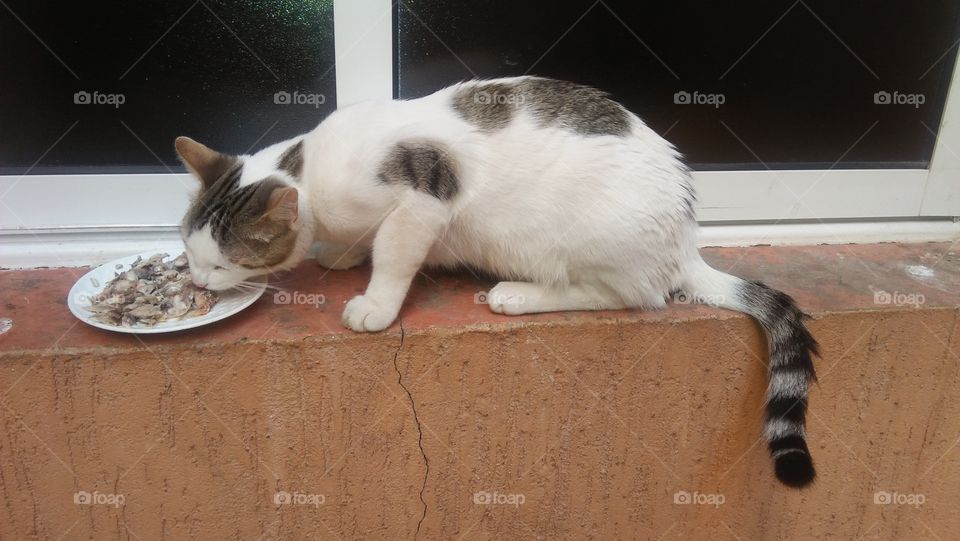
[0,0,960,268]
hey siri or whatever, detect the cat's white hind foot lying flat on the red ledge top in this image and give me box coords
[487,282,626,316]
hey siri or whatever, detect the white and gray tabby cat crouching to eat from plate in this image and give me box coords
[175,77,817,487]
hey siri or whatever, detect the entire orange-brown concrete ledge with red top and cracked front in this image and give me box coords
[0,244,960,539]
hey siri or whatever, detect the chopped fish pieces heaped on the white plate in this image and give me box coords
[87,253,219,327]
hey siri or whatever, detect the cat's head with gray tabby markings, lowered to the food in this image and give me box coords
[175,137,304,290]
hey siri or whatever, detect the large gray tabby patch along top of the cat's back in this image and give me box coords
[453,77,630,137]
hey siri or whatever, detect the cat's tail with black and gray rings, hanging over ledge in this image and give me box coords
[681,257,818,488]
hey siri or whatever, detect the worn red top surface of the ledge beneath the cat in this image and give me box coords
[0,243,960,353]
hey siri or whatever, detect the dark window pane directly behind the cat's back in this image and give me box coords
[396,0,960,169]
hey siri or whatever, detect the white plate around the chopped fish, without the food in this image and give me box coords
[67,250,267,334]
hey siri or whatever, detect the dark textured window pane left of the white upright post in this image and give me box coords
[0,0,336,174]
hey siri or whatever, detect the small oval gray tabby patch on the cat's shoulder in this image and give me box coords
[379,140,460,200]
